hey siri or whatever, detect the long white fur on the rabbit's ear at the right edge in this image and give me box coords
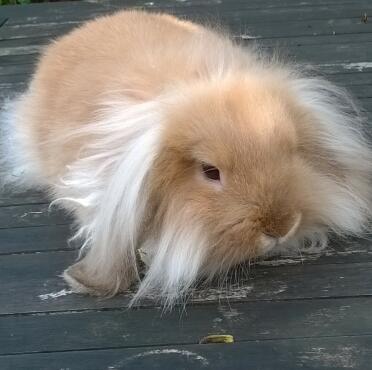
[289,77,372,235]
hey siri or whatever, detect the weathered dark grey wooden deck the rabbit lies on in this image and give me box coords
[0,0,372,370]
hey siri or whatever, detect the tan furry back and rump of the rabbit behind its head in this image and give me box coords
[15,12,232,183]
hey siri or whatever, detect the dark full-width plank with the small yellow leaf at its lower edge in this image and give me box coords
[0,297,372,354]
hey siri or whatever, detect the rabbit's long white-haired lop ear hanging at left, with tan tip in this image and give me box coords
[61,102,160,295]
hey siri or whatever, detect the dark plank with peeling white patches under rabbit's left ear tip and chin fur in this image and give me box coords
[0,246,372,314]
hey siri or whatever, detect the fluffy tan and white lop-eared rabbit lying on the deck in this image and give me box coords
[1,10,372,305]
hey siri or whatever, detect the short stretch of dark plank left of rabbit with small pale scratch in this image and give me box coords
[0,203,71,229]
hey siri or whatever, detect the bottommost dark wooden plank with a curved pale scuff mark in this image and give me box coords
[0,336,372,370]
